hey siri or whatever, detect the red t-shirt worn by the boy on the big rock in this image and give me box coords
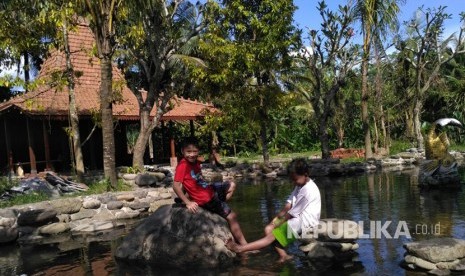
[174,158,214,205]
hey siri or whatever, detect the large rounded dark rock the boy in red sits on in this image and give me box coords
[115,205,235,268]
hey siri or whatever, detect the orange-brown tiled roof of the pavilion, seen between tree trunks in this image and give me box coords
[0,25,214,120]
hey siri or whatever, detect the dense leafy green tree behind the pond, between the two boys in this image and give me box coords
[197,0,300,161]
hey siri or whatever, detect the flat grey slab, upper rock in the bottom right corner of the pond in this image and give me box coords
[404,238,465,263]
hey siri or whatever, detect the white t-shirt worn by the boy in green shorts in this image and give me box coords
[287,179,321,235]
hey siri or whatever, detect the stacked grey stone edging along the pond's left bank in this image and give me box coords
[0,188,173,244]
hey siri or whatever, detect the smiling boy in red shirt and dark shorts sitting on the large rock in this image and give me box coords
[173,138,247,244]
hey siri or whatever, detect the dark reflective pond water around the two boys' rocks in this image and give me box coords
[0,168,465,276]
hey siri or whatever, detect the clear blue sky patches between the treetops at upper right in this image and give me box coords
[294,0,465,42]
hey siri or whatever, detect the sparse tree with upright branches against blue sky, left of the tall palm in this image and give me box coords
[289,1,360,158]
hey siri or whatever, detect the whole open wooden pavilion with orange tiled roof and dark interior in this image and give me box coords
[0,24,214,174]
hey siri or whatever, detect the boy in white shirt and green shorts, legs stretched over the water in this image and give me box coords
[226,158,321,262]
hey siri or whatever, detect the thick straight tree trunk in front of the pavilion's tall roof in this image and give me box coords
[100,57,118,190]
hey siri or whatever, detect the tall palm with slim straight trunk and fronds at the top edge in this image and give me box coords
[352,0,404,158]
